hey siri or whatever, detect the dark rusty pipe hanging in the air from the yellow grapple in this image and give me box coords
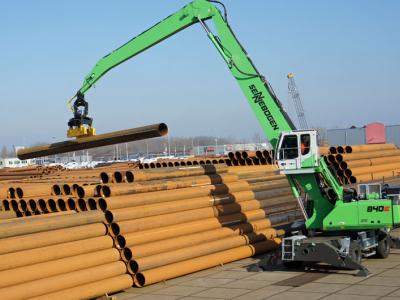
[17,123,168,159]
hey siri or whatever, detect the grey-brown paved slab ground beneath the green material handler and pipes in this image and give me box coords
[116,250,400,300]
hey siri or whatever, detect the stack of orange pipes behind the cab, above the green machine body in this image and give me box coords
[326,144,400,184]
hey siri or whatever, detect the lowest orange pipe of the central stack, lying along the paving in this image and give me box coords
[134,239,281,287]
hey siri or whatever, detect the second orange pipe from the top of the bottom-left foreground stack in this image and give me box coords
[0,223,107,254]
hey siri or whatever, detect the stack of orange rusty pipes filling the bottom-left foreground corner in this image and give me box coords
[0,211,133,299]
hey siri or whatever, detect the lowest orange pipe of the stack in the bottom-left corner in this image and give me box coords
[30,274,133,300]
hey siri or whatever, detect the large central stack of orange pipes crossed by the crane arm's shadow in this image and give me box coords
[89,165,300,287]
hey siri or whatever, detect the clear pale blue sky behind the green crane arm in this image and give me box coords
[0,0,400,145]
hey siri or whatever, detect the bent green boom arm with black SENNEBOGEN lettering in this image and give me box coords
[74,0,295,147]
